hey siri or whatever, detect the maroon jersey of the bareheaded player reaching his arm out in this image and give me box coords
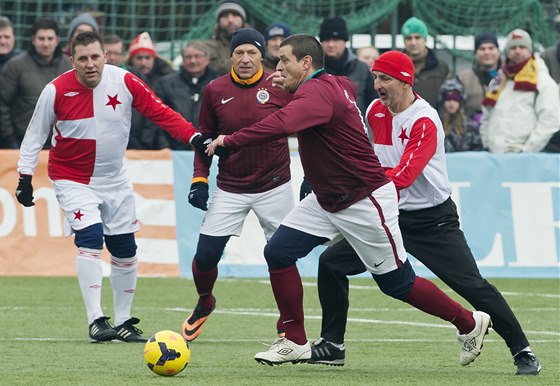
[224,72,389,212]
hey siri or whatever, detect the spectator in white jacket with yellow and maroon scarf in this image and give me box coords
[480,29,560,153]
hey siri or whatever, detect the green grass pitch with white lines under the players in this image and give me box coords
[0,277,560,386]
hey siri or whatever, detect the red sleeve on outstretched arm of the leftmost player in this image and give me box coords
[124,72,196,143]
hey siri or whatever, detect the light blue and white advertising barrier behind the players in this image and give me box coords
[173,152,560,278]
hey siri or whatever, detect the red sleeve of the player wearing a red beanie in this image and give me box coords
[385,118,437,190]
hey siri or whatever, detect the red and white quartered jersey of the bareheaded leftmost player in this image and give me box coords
[18,65,195,184]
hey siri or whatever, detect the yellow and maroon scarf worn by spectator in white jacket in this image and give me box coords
[482,56,538,107]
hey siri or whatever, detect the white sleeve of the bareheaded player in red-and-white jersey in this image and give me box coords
[18,83,56,175]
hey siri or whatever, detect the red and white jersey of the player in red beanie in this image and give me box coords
[366,97,451,210]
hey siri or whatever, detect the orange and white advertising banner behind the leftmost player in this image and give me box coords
[0,150,179,276]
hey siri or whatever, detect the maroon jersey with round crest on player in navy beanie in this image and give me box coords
[194,73,292,193]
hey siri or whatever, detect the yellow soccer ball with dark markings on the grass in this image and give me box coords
[144,330,191,376]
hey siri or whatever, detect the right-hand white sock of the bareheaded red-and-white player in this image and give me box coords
[110,256,138,326]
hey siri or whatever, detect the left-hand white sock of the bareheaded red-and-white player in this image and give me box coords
[76,248,105,324]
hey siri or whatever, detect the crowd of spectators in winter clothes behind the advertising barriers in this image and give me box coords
[0,0,560,153]
